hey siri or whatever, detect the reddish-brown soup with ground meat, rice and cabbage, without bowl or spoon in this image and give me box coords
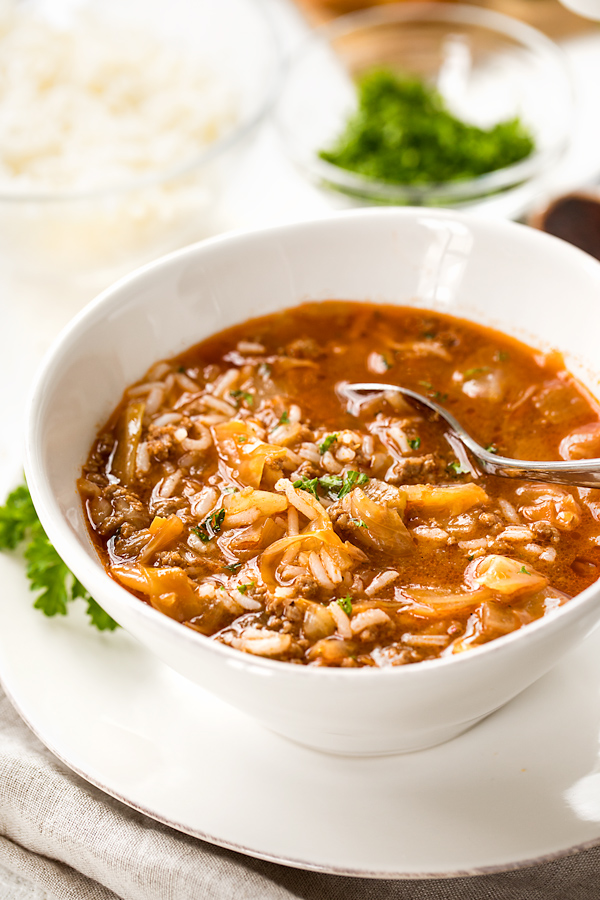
[79,301,600,667]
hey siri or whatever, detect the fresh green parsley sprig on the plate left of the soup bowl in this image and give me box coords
[0,484,119,631]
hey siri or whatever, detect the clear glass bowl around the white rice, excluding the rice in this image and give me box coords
[0,0,283,285]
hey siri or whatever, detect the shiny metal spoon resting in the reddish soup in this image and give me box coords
[337,382,600,488]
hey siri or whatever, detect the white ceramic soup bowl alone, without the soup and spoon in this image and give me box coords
[26,209,600,754]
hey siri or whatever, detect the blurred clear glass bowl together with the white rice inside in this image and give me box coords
[0,0,281,282]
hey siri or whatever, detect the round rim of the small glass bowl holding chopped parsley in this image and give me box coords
[274,0,575,205]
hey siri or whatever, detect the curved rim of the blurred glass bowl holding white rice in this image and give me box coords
[0,0,286,204]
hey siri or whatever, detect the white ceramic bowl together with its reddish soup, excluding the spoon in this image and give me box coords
[27,210,600,753]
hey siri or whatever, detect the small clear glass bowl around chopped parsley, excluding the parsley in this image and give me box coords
[276,2,573,206]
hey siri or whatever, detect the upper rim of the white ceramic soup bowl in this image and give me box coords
[24,207,600,680]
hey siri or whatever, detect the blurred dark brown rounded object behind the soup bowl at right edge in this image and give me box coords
[531,194,600,260]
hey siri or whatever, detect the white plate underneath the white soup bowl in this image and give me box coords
[0,556,600,878]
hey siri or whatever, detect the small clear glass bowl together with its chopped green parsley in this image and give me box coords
[276,2,572,206]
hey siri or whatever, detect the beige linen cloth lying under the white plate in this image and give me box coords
[0,692,600,900]
